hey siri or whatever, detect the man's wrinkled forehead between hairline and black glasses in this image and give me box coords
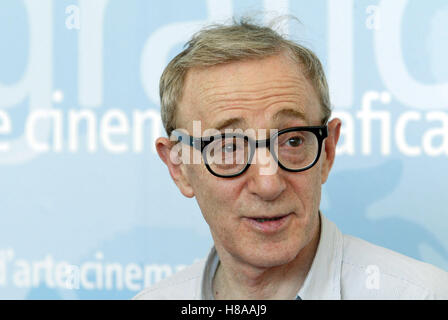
[177,54,321,129]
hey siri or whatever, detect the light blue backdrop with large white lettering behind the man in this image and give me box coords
[0,0,448,299]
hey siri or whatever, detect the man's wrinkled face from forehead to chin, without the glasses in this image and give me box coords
[164,54,337,268]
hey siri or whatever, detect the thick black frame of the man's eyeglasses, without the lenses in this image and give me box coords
[172,125,328,178]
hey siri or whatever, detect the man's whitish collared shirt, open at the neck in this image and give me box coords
[134,214,448,300]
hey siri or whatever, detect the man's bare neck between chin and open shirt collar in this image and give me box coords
[213,218,320,300]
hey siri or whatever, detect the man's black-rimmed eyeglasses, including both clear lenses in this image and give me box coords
[172,125,328,178]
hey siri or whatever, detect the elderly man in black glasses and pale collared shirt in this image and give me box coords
[135,21,448,299]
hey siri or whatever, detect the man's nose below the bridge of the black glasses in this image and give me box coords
[246,148,286,201]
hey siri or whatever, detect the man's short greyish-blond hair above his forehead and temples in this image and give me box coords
[159,18,331,136]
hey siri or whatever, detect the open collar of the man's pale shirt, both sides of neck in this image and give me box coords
[197,213,343,300]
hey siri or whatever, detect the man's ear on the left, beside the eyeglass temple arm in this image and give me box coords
[156,137,194,198]
